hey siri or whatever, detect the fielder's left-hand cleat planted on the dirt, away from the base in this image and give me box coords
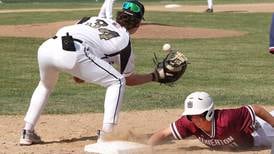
[20,129,42,145]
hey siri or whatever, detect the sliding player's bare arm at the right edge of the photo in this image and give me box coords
[252,105,274,128]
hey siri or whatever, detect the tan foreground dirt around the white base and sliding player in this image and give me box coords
[0,106,274,154]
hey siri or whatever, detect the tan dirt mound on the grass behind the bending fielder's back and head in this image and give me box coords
[0,21,246,39]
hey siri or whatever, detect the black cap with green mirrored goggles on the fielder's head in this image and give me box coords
[122,0,145,20]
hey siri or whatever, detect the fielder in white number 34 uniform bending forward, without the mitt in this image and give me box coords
[20,0,153,145]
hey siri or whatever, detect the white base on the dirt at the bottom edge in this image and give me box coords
[84,141,152,154]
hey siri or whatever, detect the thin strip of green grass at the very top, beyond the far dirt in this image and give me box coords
[0,0,273,9]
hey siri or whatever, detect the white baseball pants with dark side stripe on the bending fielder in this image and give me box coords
[25,37,125,126]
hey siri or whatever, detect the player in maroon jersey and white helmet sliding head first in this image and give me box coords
[148,92,274,149]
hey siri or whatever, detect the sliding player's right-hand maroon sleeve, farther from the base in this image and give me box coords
[220,106,255,133]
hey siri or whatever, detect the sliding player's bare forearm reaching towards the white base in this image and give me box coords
[147,127,172,145]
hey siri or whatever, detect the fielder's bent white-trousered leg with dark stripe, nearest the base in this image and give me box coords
[69,51,125,141]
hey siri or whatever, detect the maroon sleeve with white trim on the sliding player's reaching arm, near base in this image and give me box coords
[170,116,196,140]
